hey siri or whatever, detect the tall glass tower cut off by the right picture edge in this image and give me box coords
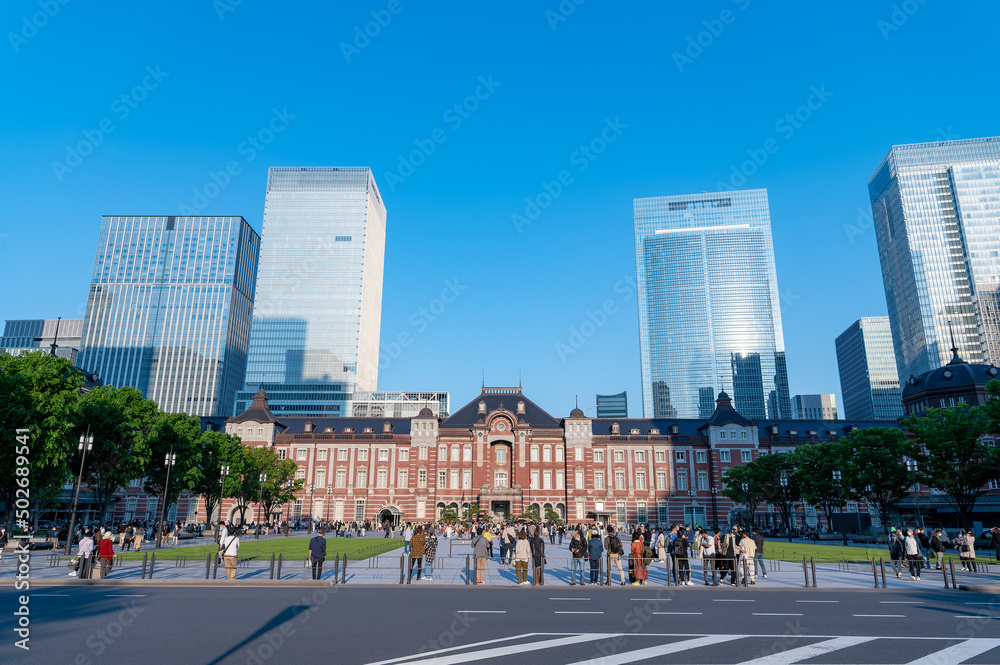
[868,136,1000,381]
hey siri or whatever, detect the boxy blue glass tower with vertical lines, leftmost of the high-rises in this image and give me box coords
[77,216,260,416]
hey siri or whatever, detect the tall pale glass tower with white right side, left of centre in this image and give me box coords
[234,167,386,416]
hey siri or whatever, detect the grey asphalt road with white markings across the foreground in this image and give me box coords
[0,586,1000,665]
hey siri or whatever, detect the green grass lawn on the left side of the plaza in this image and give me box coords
[109,536,403,561]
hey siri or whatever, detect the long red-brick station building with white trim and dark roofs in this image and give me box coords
[178,386,899,531]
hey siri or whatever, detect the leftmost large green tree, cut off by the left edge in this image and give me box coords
[0,351,84,527]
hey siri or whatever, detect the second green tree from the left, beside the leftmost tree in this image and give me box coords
[80,386,161,520]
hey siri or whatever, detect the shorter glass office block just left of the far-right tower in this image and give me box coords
[837,316,903,420]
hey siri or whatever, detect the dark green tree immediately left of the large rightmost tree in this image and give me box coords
[841,427,917,534]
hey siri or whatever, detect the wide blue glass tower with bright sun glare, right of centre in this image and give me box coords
[633,189,791,420]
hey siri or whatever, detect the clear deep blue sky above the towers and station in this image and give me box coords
[0,0,1000,416]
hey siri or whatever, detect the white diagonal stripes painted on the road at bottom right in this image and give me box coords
[368,633,1000,665]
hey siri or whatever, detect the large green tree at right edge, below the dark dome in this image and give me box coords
[900,406,1000,528]
